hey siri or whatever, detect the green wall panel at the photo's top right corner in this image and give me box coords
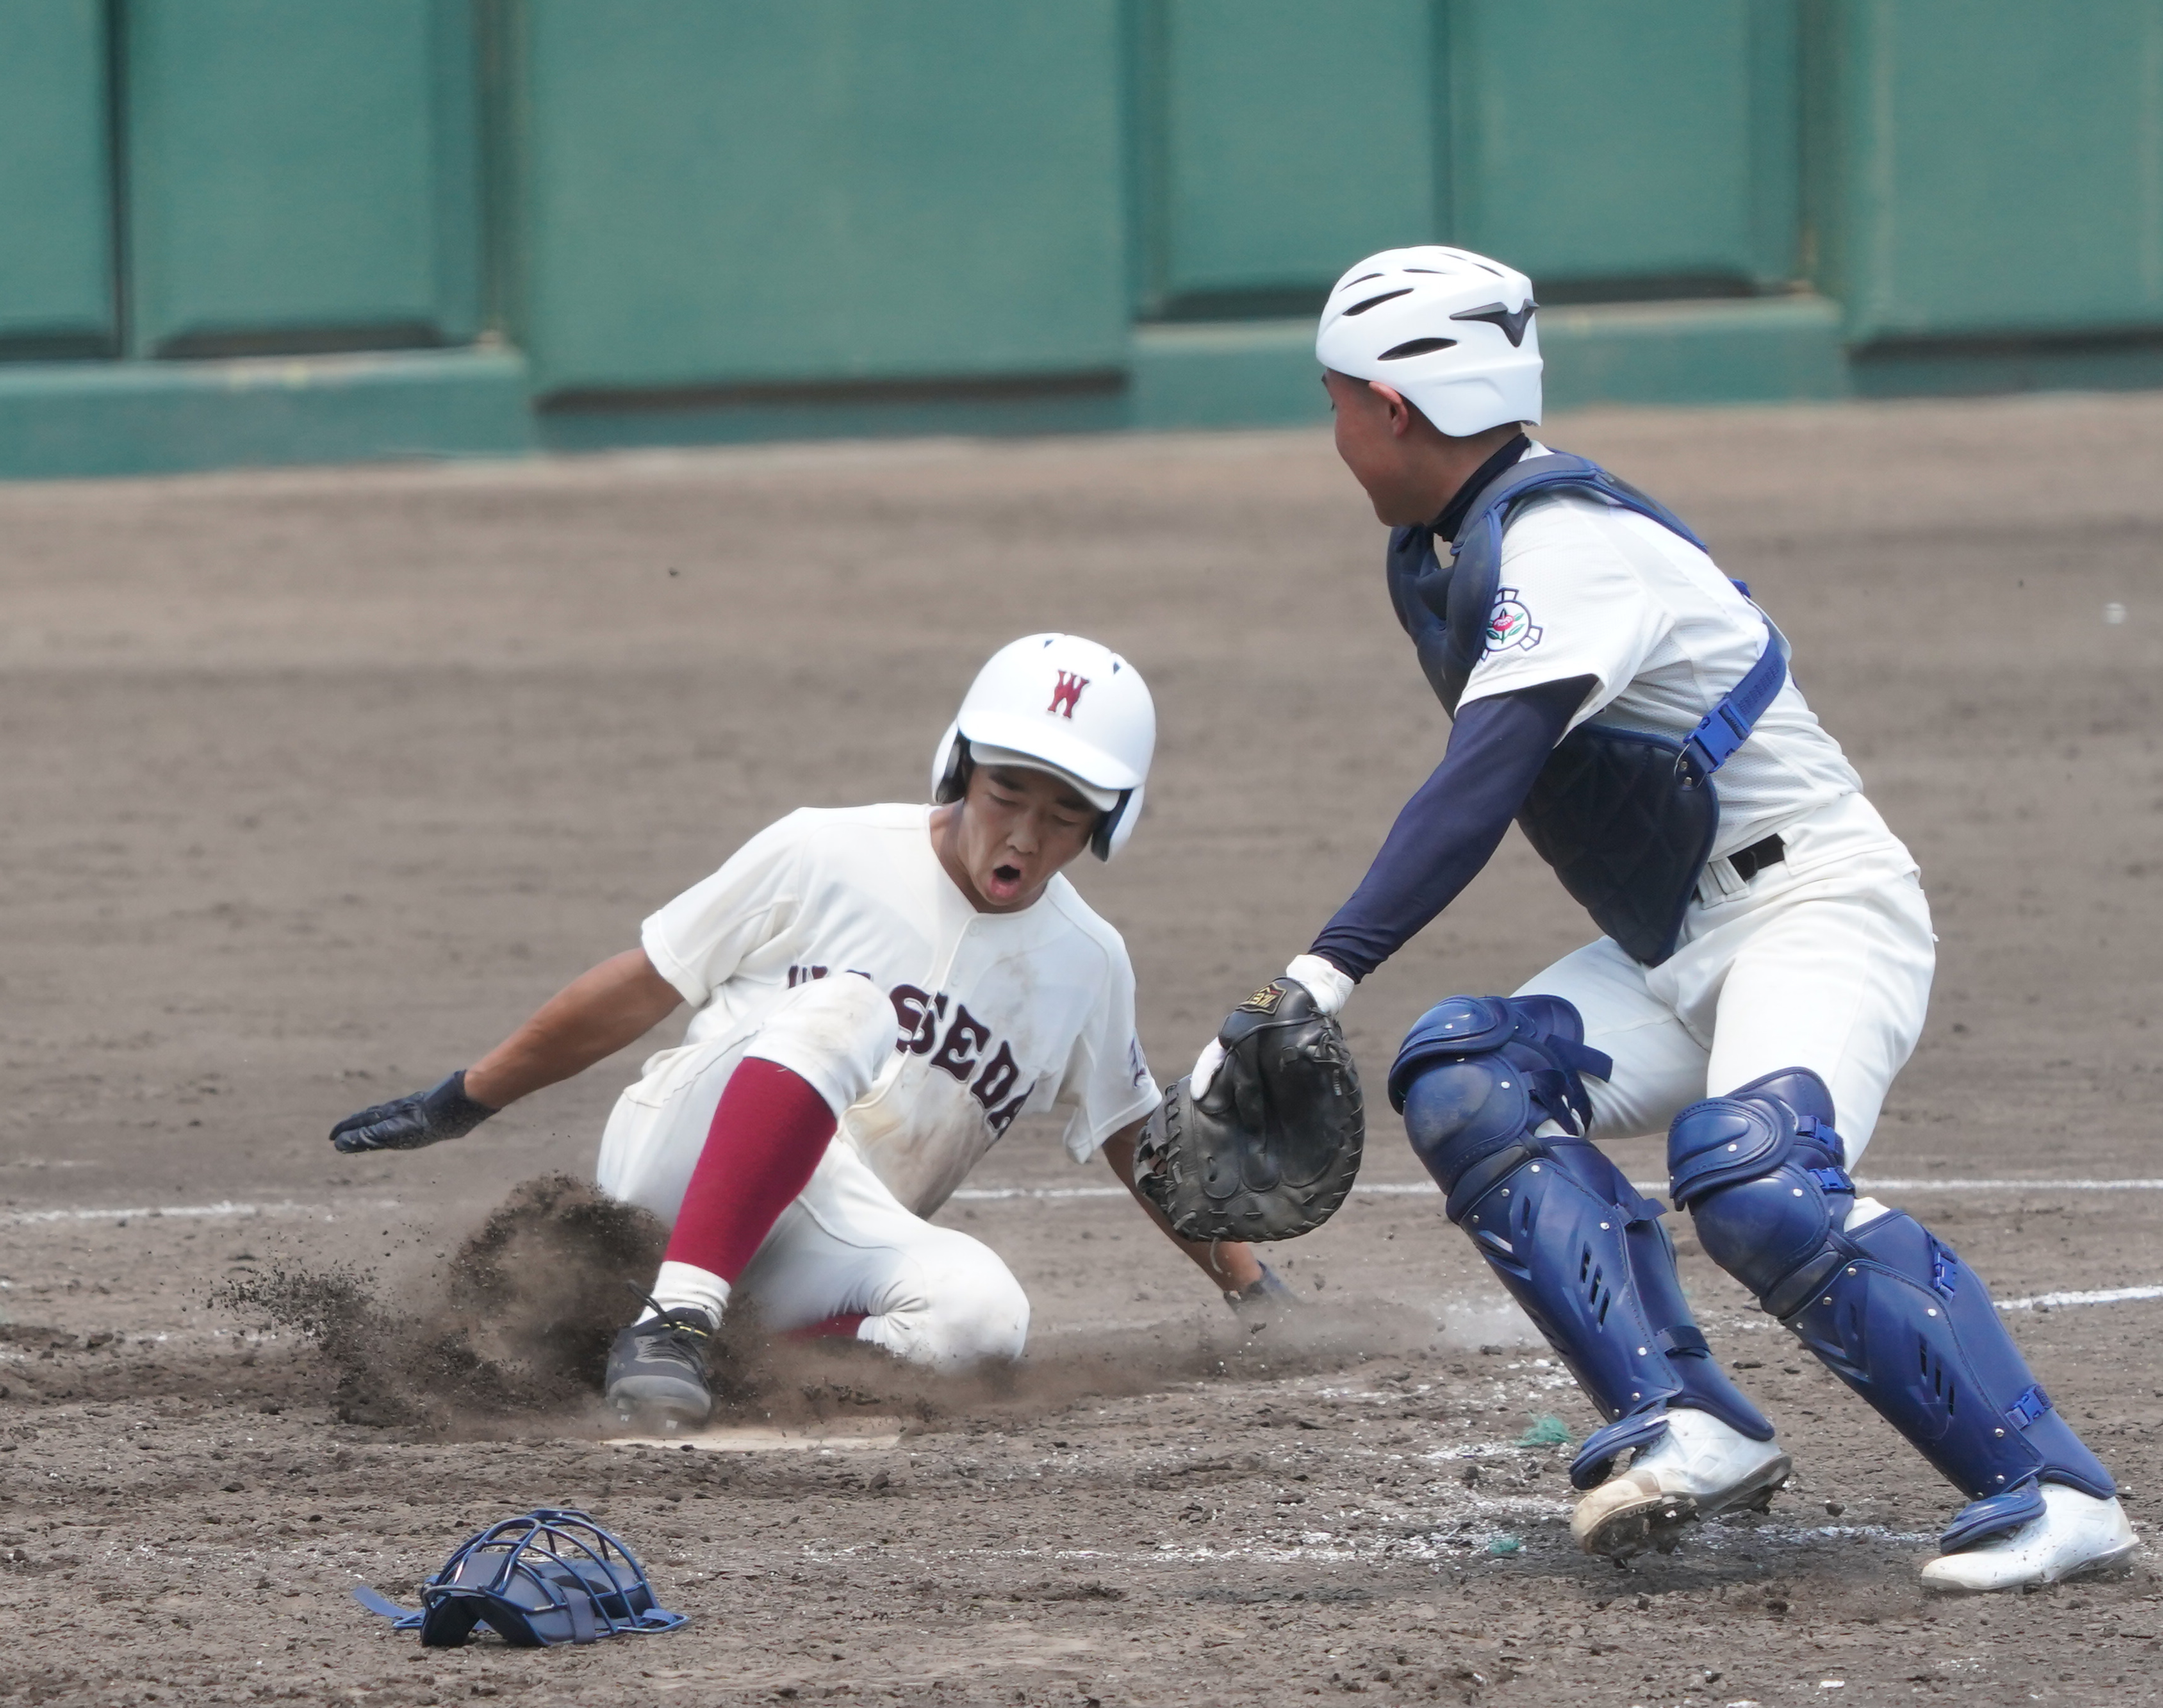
[1819,0,2163,339]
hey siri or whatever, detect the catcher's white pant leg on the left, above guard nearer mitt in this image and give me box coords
[1516,936,1709,1139]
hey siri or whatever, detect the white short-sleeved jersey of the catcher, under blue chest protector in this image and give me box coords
[1460,445,1862,856]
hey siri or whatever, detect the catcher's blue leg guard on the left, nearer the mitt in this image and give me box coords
[1389,997,1772,1487]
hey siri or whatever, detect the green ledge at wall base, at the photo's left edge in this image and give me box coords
[0,350,534,480]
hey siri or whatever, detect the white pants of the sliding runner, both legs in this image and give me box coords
[595,975,1029,1369]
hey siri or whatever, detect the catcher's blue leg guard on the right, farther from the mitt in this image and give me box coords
[1667,1068,2115,1550]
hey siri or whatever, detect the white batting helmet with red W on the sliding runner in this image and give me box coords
[932,636,1157,860]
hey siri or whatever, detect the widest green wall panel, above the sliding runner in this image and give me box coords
[519,0,1127,389]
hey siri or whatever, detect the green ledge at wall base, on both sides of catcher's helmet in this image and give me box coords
[1129,296,1849,428]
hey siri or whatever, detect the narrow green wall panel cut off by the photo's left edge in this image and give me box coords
[0,0,115,354]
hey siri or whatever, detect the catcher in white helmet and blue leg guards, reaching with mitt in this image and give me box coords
[1142,246,2135,1589]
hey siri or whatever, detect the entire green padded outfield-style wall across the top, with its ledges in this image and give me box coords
[0,0,2163,473]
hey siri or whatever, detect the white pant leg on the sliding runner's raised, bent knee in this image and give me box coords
[595,973,893,1224]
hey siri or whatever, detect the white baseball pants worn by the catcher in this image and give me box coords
[1516,795,1938,1168]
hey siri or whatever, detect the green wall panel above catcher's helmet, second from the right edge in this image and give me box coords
[1447,0,1800,288]
